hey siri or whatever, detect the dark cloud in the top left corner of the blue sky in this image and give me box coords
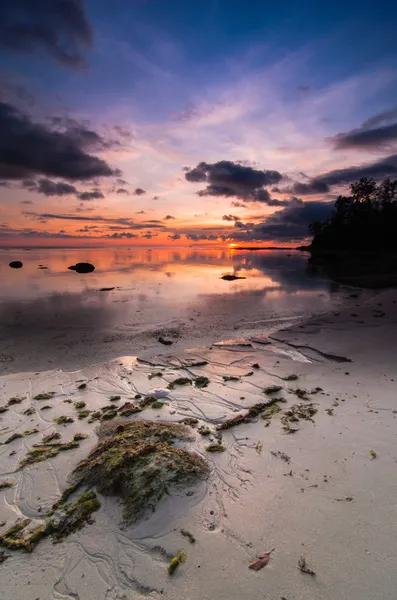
[0,0,92,68]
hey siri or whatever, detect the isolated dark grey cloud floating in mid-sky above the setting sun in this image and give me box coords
[185,160,283,206]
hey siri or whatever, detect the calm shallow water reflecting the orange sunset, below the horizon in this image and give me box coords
[0,247,358,371]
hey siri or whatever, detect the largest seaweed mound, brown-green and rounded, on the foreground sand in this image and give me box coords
[72,420,208,523]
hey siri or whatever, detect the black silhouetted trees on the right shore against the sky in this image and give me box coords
[309,177,397,250]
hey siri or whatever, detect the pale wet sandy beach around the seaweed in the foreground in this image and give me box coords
[0,291,397,600]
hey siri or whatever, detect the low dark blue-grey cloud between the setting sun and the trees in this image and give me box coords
[229,198,334,242]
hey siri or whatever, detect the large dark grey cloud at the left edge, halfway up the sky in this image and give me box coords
[0,102,118,181]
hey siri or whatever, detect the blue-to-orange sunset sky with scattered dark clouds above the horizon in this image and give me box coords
[0,0,397,246]
